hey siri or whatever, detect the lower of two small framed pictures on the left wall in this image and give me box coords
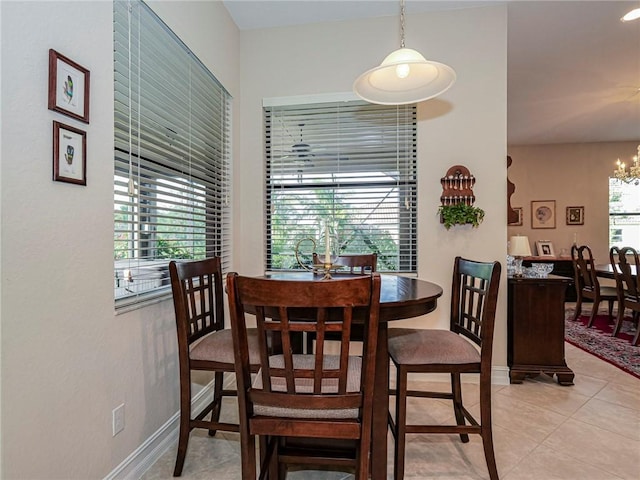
[53,122,87,185]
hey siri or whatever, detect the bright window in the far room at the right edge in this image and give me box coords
[609,178,640,249]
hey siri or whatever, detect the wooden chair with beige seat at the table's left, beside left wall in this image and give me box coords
[169,257,258,477]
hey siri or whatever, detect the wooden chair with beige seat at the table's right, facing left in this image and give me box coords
[389,257,501,480]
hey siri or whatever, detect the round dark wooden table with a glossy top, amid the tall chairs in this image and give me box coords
[265,272,442,480]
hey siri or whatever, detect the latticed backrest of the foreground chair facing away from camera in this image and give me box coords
[227,274,380,410]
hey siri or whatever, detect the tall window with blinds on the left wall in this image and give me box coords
[114,1,231,307]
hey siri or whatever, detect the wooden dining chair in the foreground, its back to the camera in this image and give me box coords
[227,273,380,480]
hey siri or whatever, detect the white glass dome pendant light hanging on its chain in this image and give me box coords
[353,0,456,105]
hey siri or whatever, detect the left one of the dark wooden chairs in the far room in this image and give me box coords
[571,245,618,328]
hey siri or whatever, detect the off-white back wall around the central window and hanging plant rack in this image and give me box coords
[234,6,507,360]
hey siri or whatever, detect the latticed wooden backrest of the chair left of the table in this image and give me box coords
[169,257,224,345]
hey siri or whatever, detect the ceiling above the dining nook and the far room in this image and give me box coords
[224,0,640,145]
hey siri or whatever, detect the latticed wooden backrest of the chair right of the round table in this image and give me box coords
[451,257,500,346]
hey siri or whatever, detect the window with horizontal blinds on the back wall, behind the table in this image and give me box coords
[264,101,417,272]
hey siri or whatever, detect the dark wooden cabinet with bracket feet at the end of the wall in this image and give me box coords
[507,275,574,385]
